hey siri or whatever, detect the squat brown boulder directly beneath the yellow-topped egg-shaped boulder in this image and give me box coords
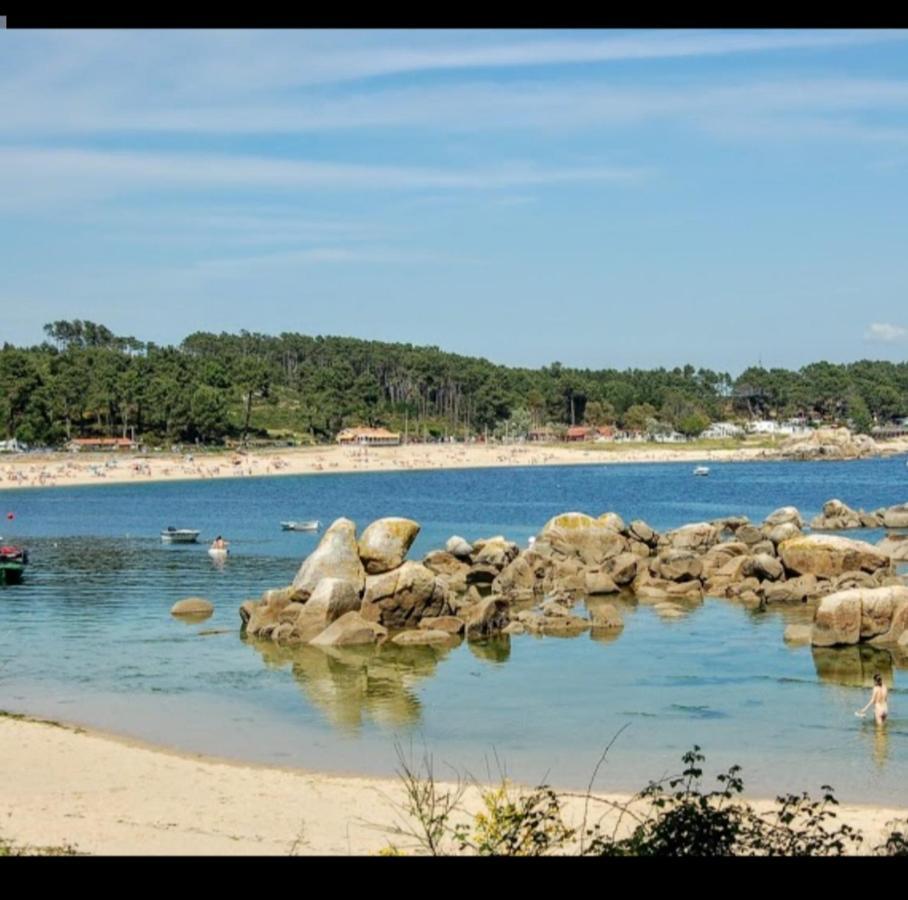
[361,562,448,629]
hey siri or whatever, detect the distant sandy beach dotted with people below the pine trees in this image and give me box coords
[0,443,908,492]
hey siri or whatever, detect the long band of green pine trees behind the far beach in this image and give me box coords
[0,320,908,445]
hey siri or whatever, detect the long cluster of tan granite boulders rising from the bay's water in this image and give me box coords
[240,500,908,646]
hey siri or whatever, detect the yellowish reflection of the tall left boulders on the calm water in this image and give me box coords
[245,638,458,734]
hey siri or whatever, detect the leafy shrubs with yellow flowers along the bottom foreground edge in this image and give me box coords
[388,746,888,857]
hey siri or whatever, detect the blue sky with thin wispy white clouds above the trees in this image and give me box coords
[0,30,908,375]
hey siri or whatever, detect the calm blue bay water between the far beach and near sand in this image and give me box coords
[0,458,908,805]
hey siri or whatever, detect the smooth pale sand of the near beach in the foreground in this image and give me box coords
[0,713,908,855]
